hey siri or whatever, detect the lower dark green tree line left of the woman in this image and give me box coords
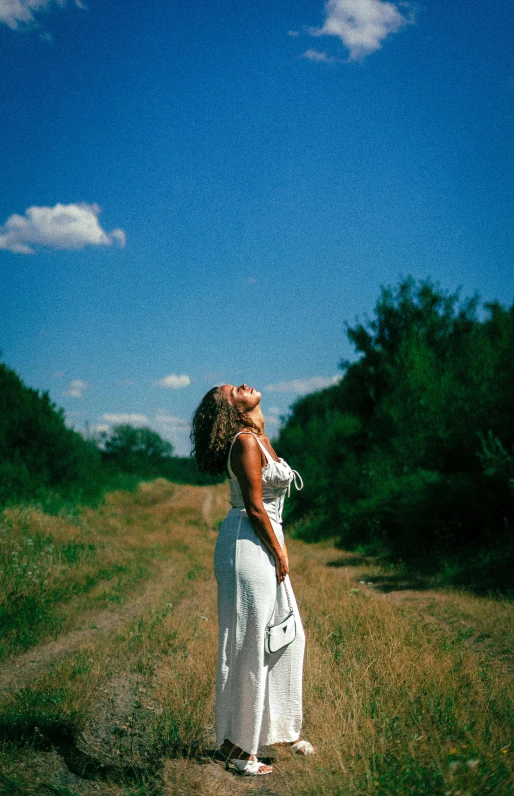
[0,363,216,505]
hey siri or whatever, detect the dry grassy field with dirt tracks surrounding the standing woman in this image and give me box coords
[0,480,514,796]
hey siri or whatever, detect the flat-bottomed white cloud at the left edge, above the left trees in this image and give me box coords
[0,202,125,254]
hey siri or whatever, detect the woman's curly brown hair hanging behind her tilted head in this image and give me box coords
[190,387,258,475]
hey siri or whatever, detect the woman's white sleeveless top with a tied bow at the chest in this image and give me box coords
[227,431,303,522]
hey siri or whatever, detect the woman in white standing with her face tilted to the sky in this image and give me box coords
[191,384,314,776]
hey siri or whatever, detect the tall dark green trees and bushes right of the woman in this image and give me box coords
[277,278,514,582]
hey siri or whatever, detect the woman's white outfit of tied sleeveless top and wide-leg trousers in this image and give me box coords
[214,432,305,754]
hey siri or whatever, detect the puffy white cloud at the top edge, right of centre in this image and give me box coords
[310,0,412,61]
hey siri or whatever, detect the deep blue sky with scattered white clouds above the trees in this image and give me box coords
[0,0,514,454]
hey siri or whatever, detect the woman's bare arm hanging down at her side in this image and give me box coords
[230,434,289,583]
